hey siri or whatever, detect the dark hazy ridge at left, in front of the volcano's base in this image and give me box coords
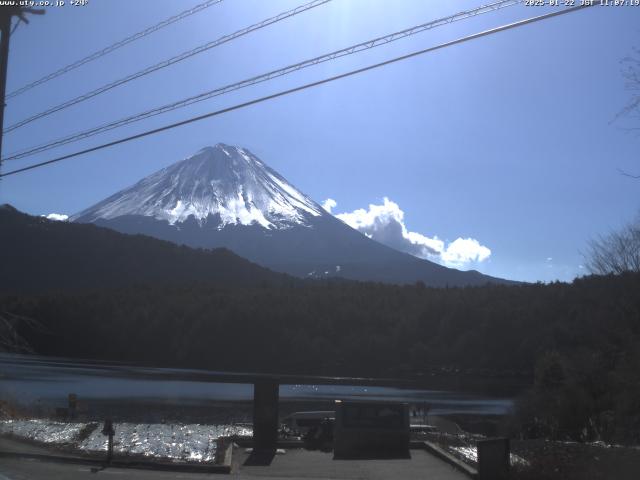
[0,205,294,293]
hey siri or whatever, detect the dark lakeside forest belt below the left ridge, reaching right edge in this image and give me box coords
[0,273,640,442]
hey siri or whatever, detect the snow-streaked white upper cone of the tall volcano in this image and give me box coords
[71,143,324,229]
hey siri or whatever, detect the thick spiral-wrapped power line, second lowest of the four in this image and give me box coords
[5,0,524,160]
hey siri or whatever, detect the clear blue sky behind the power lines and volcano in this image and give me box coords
[0,0,640,281]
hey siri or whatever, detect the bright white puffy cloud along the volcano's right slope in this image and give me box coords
[322,197,491,268]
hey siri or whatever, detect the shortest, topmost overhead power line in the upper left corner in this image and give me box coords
[7,0,222,99]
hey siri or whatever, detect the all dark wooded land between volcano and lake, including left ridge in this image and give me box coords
[0,202,640,443]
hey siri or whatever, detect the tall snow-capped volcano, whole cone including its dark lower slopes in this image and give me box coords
[70,143,509,286]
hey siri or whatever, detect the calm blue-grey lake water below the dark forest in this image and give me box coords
[0,354,513,415]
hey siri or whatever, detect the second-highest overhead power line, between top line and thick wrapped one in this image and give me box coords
[4,0,331,133]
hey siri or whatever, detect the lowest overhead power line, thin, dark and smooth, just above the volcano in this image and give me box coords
[0,3,595,178]
